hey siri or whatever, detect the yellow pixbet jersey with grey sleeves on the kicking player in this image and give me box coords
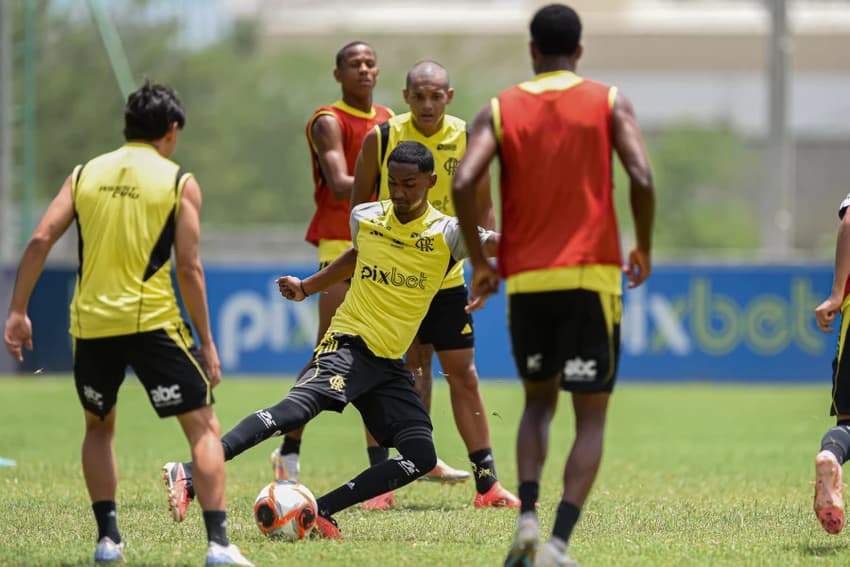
[328,201,492,359]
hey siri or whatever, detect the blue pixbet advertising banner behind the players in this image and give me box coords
[26,265,837,382]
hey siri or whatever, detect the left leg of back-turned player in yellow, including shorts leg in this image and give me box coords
[74,337,126,563]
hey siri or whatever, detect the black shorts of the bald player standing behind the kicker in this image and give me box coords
[416,285,475,352]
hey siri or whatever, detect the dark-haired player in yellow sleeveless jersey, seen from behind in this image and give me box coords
[3,83,251,565]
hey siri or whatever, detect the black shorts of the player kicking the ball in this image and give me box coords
[293,335,432,447]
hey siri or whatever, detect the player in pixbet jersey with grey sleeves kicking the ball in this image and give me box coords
[161,142,498,538]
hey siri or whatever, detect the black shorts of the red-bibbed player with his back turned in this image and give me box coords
[508,289,622,392]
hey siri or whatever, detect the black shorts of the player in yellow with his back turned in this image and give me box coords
[74,323,213,417]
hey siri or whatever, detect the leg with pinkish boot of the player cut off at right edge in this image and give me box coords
[814,304,850,534]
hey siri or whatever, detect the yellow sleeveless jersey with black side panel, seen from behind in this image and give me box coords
[71,143,191,339]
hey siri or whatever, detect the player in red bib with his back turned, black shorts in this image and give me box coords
[453,4,655,567]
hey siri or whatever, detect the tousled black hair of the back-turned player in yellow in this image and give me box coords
[124,81,186,140]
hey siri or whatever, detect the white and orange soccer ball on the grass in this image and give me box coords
[254,480,317,541]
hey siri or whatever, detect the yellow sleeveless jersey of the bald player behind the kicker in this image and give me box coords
[374,112,467,288]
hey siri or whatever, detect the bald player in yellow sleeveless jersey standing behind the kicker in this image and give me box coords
[352,61,519,509]
